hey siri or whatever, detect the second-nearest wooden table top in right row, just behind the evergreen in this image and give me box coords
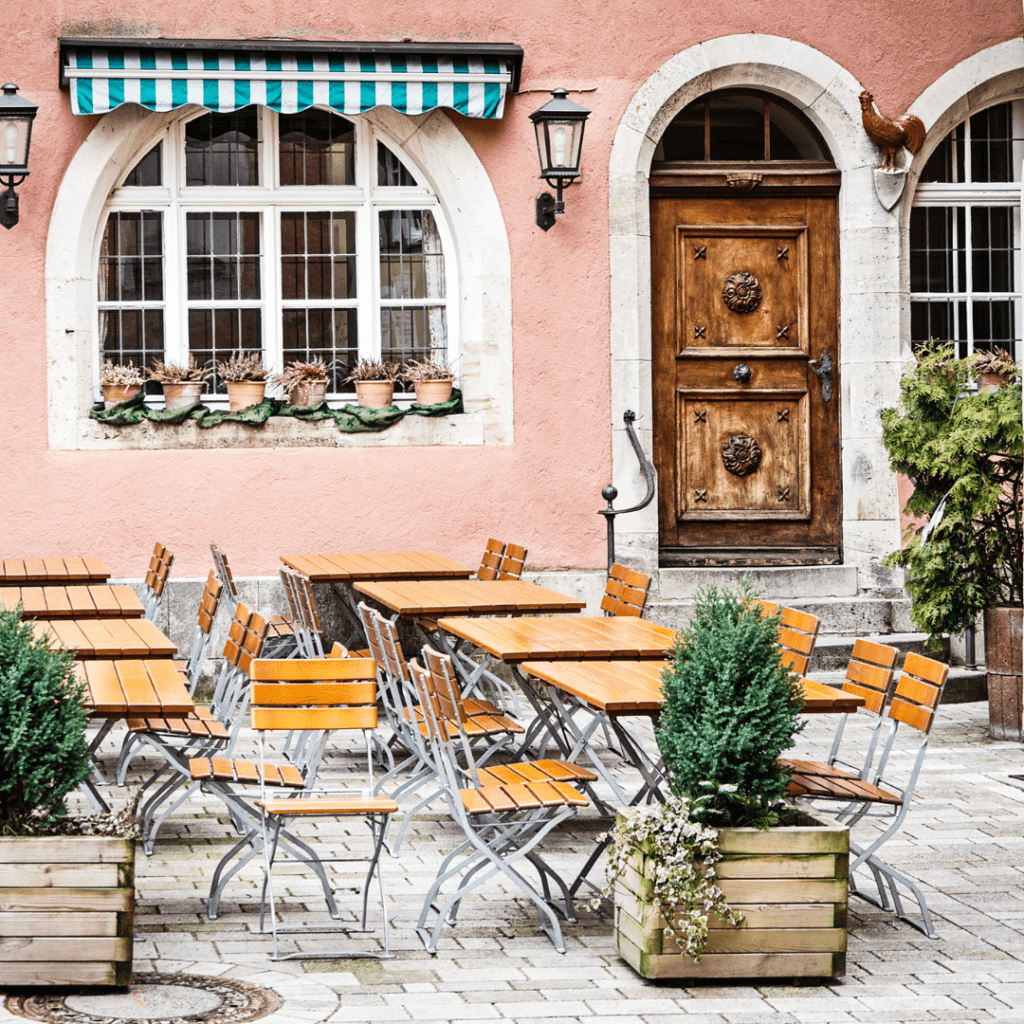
[437,615,676,665]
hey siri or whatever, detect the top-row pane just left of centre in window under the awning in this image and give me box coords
[185,106,259,185]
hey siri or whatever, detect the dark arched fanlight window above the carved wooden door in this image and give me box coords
[654,89,831,166]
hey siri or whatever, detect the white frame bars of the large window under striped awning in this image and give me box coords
[92,106,461,407]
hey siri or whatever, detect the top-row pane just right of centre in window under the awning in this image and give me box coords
[278,110,355,185]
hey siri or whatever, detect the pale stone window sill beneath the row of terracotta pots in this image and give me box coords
[77,411,485,452]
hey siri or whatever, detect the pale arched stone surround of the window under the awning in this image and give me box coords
[46,104,512,449]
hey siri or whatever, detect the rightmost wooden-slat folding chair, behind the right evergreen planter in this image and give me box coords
[790,653,949,939]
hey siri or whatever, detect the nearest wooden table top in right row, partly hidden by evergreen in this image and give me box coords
[519,662,864,715]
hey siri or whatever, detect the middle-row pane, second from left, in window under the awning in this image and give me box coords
[185,212,261,301]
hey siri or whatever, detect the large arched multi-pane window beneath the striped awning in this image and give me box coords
[95,106,457,396]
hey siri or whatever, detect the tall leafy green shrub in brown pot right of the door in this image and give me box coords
[882,345,1024,740]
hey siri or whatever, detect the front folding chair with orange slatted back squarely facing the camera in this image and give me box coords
[251,658,398,961]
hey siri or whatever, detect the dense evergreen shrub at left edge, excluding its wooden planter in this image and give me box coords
[0,608,92,836]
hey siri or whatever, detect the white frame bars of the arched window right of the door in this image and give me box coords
[910,97,1024,364]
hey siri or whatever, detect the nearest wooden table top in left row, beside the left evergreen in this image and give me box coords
[75,658,196,718]
